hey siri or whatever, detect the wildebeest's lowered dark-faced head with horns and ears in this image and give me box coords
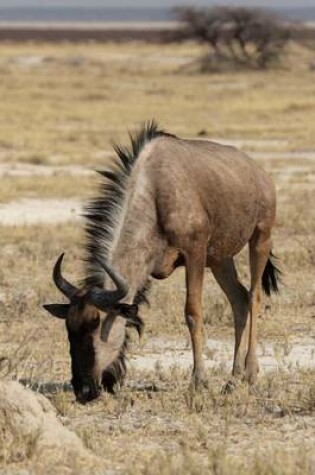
[44,254,143,403]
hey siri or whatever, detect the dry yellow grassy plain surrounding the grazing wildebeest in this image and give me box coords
[0,39,315,475]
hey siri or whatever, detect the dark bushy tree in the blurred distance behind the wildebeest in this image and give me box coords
[176,7,290,68]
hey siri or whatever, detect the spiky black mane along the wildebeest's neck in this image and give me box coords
[83,120,175,304]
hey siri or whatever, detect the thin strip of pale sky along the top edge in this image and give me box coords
[0,0,315,8]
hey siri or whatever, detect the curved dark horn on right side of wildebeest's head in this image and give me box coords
[89,260,128,310]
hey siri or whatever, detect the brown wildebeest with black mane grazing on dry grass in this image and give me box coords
[45,122,277,402]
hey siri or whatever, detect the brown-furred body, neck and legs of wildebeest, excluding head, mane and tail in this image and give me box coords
[104,133,276,384]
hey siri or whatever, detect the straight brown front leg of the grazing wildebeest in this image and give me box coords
[185,253,206,388]
